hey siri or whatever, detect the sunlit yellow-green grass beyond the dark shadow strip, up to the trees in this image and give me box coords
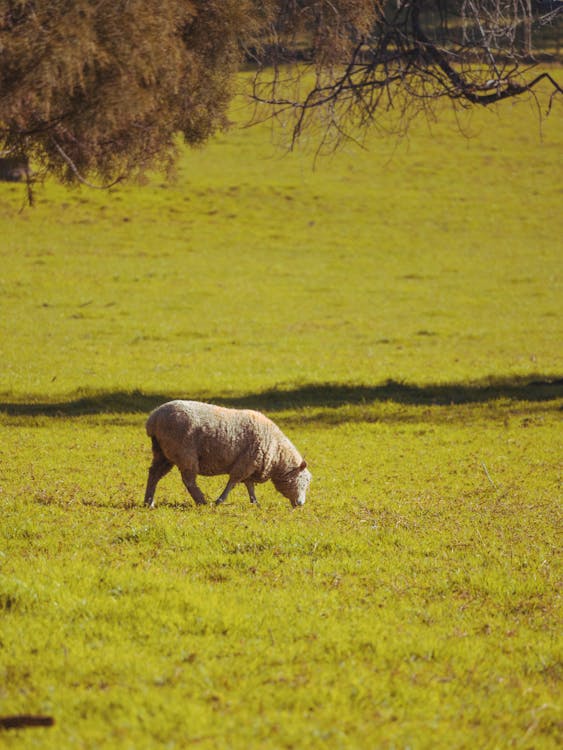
[0,81,562,397]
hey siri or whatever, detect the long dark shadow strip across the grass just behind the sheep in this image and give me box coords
[0,375,563,417]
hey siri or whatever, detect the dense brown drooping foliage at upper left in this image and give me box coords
[0,0,258,186]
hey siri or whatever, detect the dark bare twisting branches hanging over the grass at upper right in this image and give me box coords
[251,0,563,147]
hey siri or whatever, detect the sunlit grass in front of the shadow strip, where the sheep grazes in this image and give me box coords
[0,403,560,747]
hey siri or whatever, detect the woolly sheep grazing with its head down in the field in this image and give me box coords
[145,401,311,508]
